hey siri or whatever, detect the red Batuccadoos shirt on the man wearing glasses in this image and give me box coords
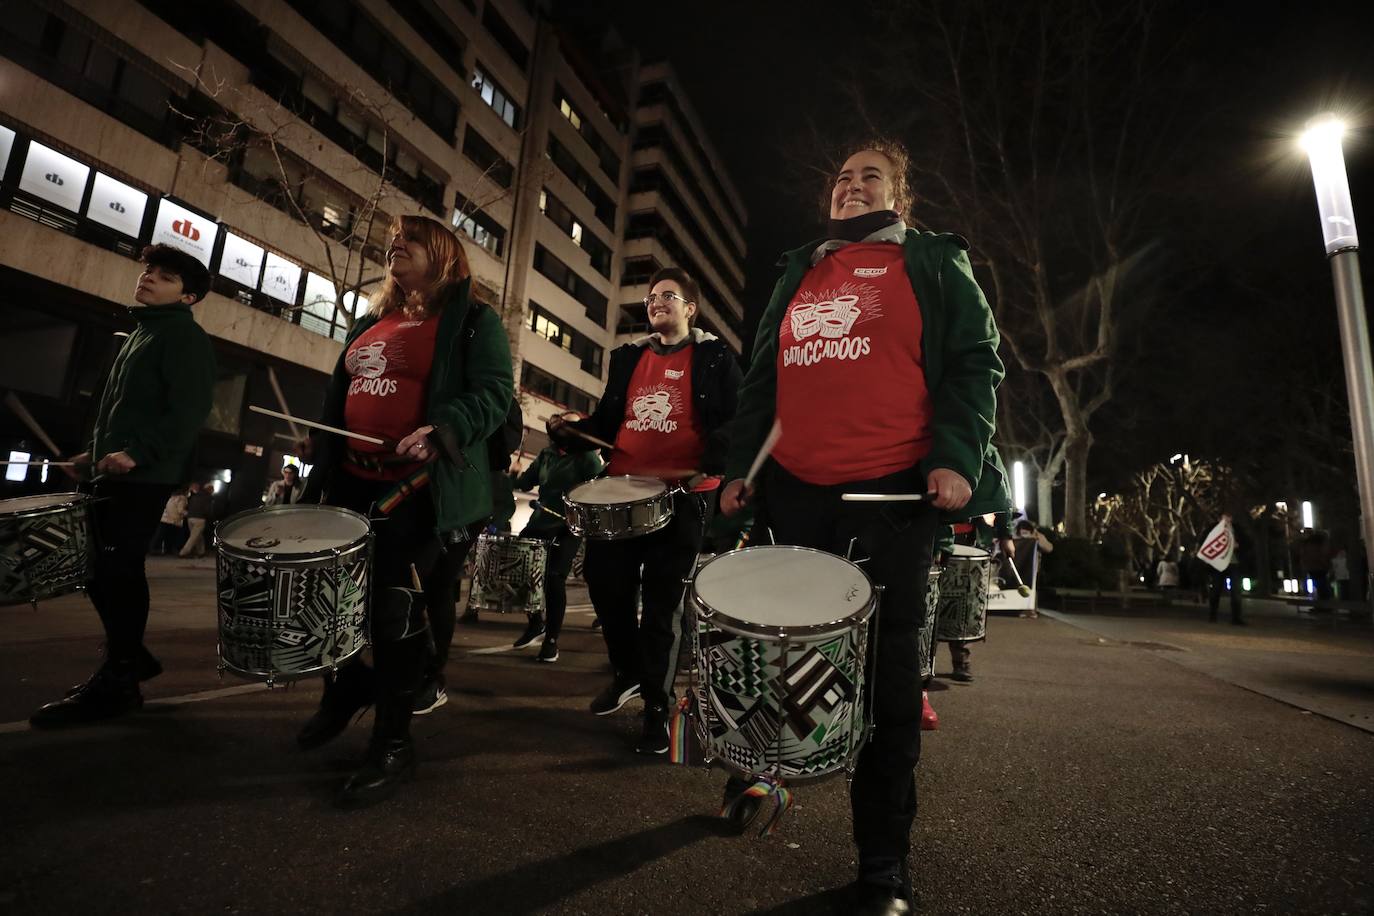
[607,343,719,489]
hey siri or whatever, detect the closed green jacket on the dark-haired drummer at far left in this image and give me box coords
[89,305,216,483]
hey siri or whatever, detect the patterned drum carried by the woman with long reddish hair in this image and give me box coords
[214,504,372,684]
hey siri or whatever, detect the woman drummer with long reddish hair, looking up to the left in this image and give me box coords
[297,217,513,806]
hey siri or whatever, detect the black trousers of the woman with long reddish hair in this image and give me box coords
[326,468,440,739]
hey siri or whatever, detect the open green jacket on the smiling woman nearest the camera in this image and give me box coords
[725,229,1011,522]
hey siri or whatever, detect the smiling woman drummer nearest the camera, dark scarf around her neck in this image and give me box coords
[720,141,1009,913]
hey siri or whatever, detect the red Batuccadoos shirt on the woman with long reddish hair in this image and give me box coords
[344,312,438,481]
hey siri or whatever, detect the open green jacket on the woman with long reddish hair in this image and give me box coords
[310,280,515,531]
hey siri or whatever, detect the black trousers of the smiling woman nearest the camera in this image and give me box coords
[752,461,938,878]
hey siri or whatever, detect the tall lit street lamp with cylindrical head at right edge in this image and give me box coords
[1303,114,1374,601]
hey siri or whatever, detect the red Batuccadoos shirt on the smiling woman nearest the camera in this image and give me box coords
[774,242,933,485]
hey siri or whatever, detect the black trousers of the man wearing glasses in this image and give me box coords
[585,493,708,715]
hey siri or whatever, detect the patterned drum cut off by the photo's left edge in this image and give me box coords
[0,493,92,604]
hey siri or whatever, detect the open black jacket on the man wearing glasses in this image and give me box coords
[559,328,743,474]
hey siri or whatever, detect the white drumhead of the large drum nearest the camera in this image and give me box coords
[692,547,872,628]
